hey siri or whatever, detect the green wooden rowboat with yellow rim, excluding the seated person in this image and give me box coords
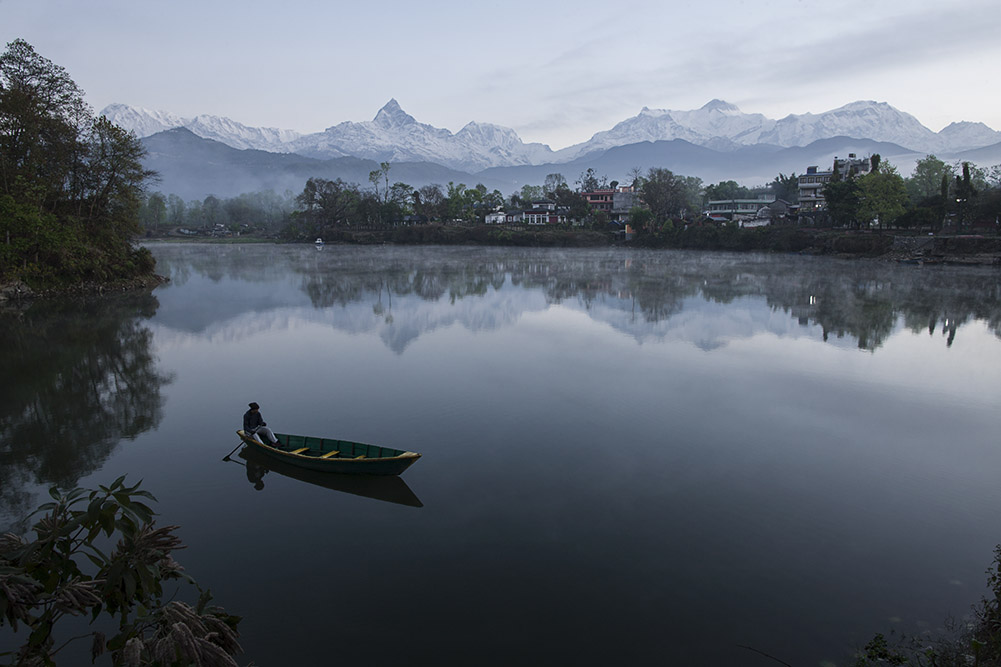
[236,429,420,475]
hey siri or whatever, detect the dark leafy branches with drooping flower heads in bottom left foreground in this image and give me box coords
[0,476,241,666]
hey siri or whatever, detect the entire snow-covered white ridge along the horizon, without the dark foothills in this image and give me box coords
[102,99,1001,172]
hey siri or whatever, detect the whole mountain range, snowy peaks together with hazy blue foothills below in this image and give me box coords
[102,99,1001,196]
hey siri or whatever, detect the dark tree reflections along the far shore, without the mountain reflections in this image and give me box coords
[291,248,1001,351]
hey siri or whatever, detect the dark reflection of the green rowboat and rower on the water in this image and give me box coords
[237,447,424,507]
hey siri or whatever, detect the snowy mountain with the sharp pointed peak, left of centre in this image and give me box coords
[291,99,553,171]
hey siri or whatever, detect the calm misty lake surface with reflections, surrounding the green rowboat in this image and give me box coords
[0,244,1001,666]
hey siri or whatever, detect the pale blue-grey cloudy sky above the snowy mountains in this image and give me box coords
[0,0,1001,149]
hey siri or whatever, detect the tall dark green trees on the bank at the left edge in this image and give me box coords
[0,39,154,287]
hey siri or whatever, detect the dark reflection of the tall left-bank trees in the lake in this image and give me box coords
[0,293,169,518]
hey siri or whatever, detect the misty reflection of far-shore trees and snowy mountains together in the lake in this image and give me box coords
[154,241,1001,353]
